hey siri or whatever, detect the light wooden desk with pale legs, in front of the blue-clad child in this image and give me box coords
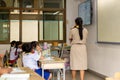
[40,57,65,80]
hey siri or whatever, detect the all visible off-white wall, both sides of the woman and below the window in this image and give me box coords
[0,0,120,76]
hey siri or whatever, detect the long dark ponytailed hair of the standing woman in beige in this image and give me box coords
[75,17,83,40]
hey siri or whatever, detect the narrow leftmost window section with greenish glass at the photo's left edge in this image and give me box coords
[0,9,10,42]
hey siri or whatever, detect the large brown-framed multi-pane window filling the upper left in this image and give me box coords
[0,0,66,43]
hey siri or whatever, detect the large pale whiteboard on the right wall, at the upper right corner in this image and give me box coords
[97,0,120,43]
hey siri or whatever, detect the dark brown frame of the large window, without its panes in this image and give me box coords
[0,0,66,44]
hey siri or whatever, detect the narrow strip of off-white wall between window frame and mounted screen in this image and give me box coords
[66,0,80,42]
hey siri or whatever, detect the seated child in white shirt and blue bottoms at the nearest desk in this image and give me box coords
[22,43,52,80]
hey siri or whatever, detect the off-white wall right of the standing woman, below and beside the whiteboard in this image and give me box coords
[87,0,120,76]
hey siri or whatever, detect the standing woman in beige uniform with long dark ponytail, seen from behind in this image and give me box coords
[69,17,88,80]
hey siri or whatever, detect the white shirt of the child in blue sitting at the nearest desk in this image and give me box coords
[23,51,40,70]
